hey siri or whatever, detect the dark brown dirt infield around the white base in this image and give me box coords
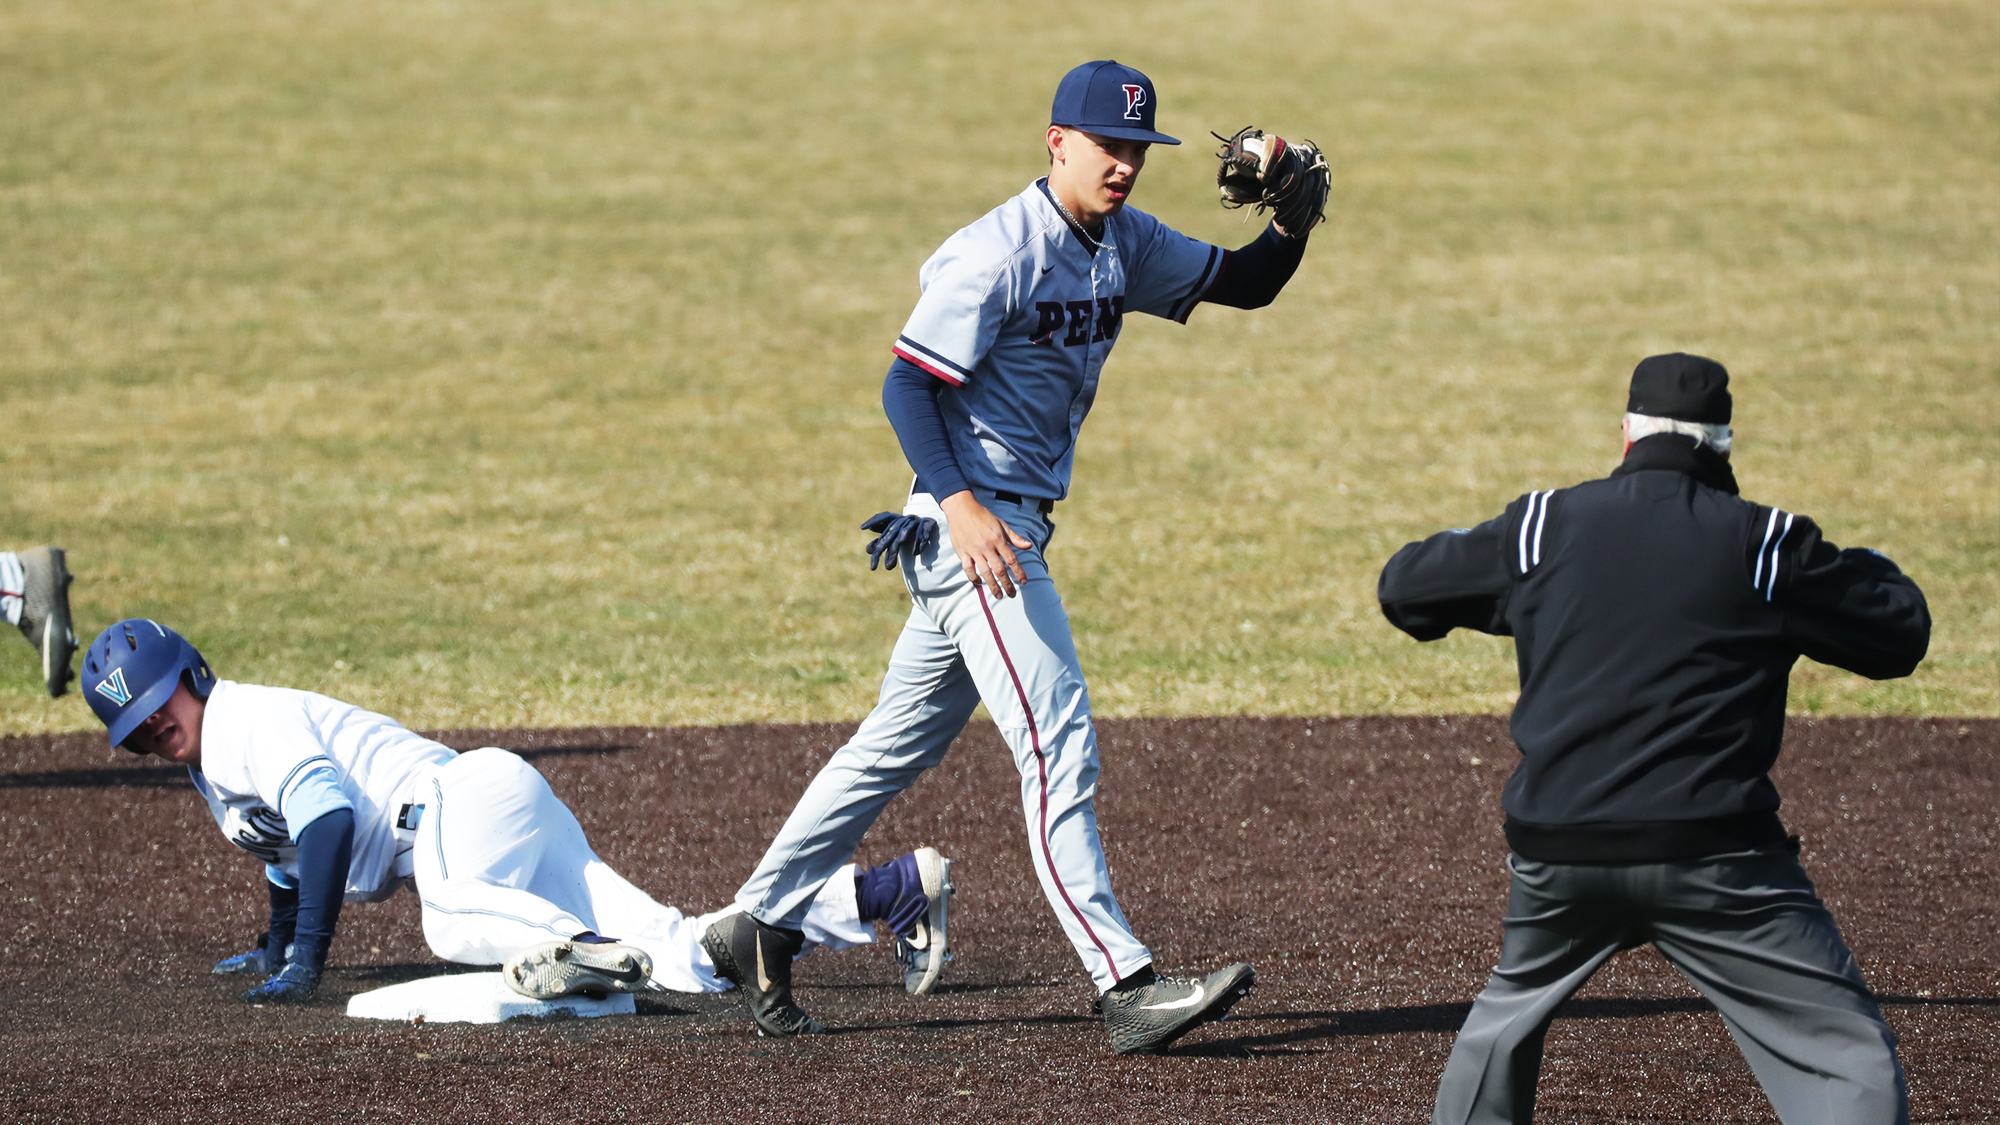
[0,717,2000,1125]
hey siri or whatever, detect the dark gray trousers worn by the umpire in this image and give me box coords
[1432,847,1910,1125]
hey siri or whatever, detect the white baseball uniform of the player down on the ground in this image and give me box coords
[188,681,874,993]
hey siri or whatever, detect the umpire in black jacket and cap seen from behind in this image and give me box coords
[1378,352,1930,1125]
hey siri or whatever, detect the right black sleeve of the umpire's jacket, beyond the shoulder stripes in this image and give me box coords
[1774,516,1930,681]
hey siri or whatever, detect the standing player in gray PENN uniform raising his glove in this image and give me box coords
[706,62,1328,1053]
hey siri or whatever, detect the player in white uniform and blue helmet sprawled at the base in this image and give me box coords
[84,619,952,1003]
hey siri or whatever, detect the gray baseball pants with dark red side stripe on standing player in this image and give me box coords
[736,492,1152,991]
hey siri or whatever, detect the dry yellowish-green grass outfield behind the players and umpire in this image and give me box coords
[0,0,2000,731]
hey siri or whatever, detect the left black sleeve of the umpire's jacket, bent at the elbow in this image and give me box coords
[1376,514,1514,641]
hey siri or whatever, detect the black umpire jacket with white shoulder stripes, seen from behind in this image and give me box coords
[1376,434,1930,863]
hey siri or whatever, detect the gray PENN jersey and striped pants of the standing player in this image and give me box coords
[736,180,1226,991]
